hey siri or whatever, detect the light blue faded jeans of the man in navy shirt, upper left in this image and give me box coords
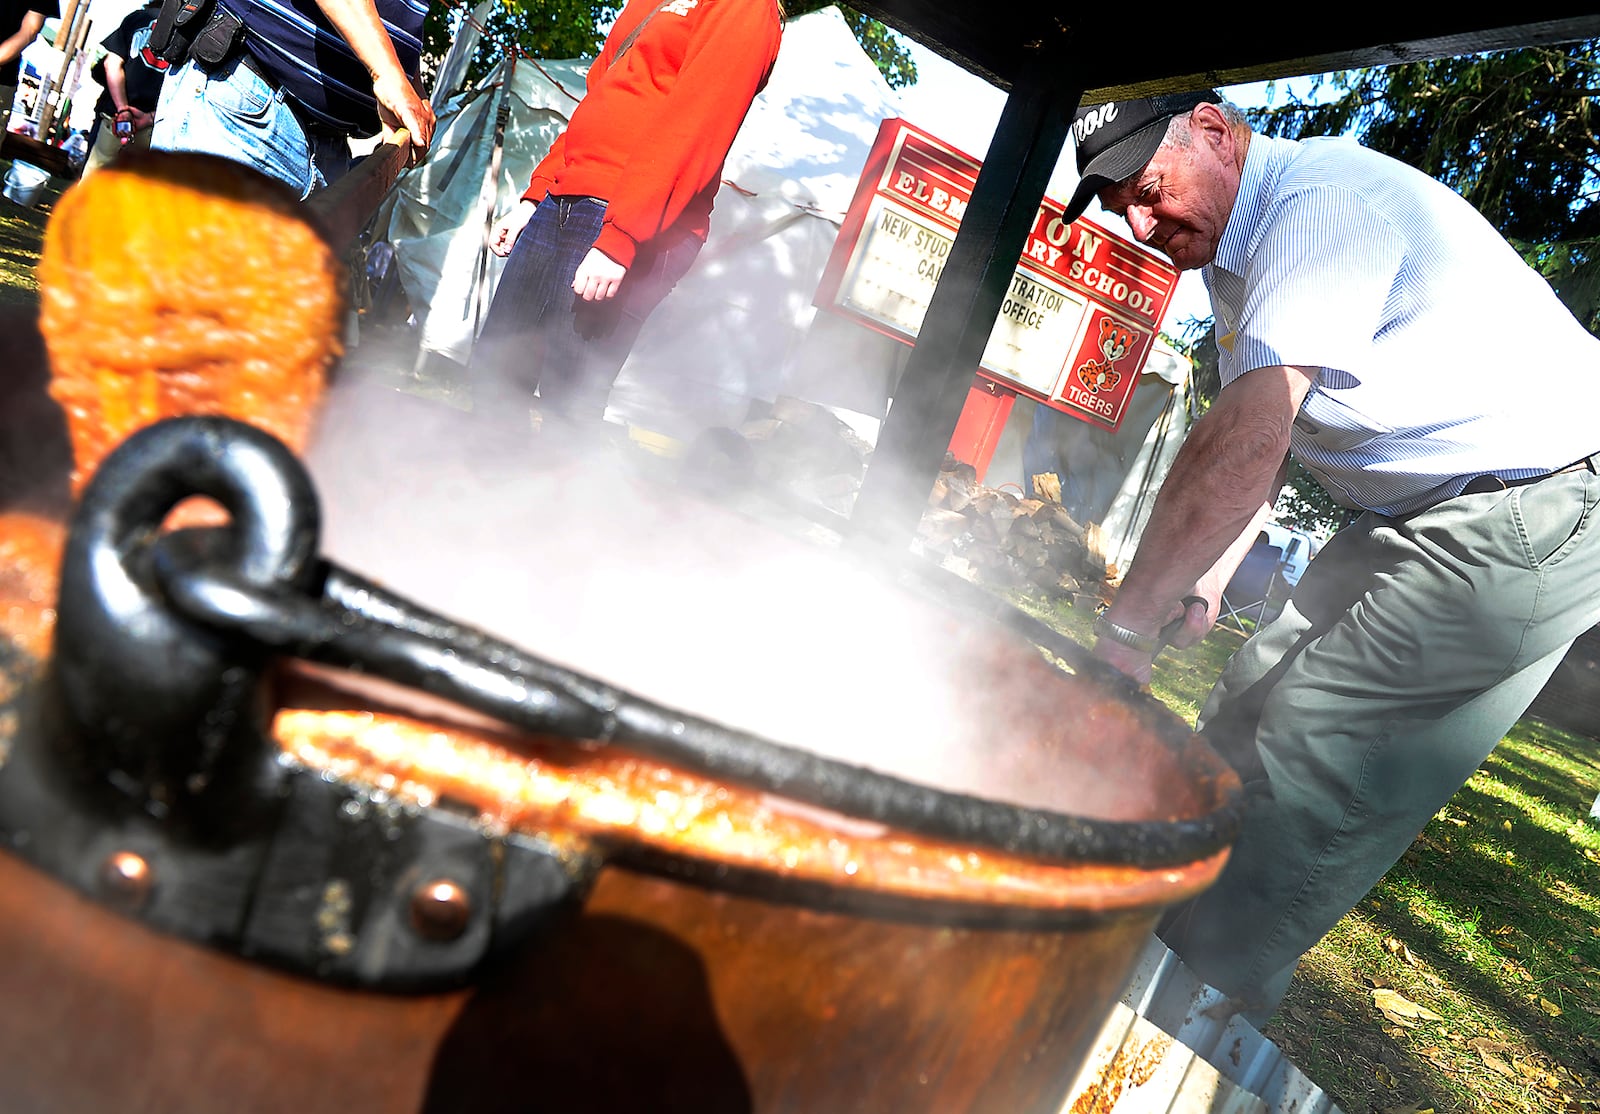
[150,58,350,200]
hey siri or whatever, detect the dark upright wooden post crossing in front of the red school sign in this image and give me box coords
[850,26,1083,552]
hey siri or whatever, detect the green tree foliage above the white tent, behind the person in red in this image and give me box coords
[424,0,917,88]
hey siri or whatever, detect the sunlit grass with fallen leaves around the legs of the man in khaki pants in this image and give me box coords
[1022,602,1600,1114]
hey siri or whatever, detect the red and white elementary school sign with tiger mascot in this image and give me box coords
[816,120,1178,429]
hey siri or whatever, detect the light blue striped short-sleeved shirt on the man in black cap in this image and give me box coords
[1203,134,1600,515]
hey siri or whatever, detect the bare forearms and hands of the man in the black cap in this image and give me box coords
[1094,367,1317,682]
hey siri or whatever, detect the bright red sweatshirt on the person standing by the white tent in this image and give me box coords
[523,0,782,267]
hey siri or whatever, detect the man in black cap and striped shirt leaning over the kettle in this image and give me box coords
[1069,91,1600,1023]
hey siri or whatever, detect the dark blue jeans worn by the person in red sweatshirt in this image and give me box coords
[472,197,701,429]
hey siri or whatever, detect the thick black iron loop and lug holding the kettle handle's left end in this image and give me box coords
[51,418,320,837]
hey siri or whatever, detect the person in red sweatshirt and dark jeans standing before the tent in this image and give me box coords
[472,0,782,444]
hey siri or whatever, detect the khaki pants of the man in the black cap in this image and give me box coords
[1160,457,1600,1024]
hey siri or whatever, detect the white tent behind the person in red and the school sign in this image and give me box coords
[387,8,1187,559]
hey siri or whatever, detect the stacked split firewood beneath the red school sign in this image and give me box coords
[918,455,1117,602]
